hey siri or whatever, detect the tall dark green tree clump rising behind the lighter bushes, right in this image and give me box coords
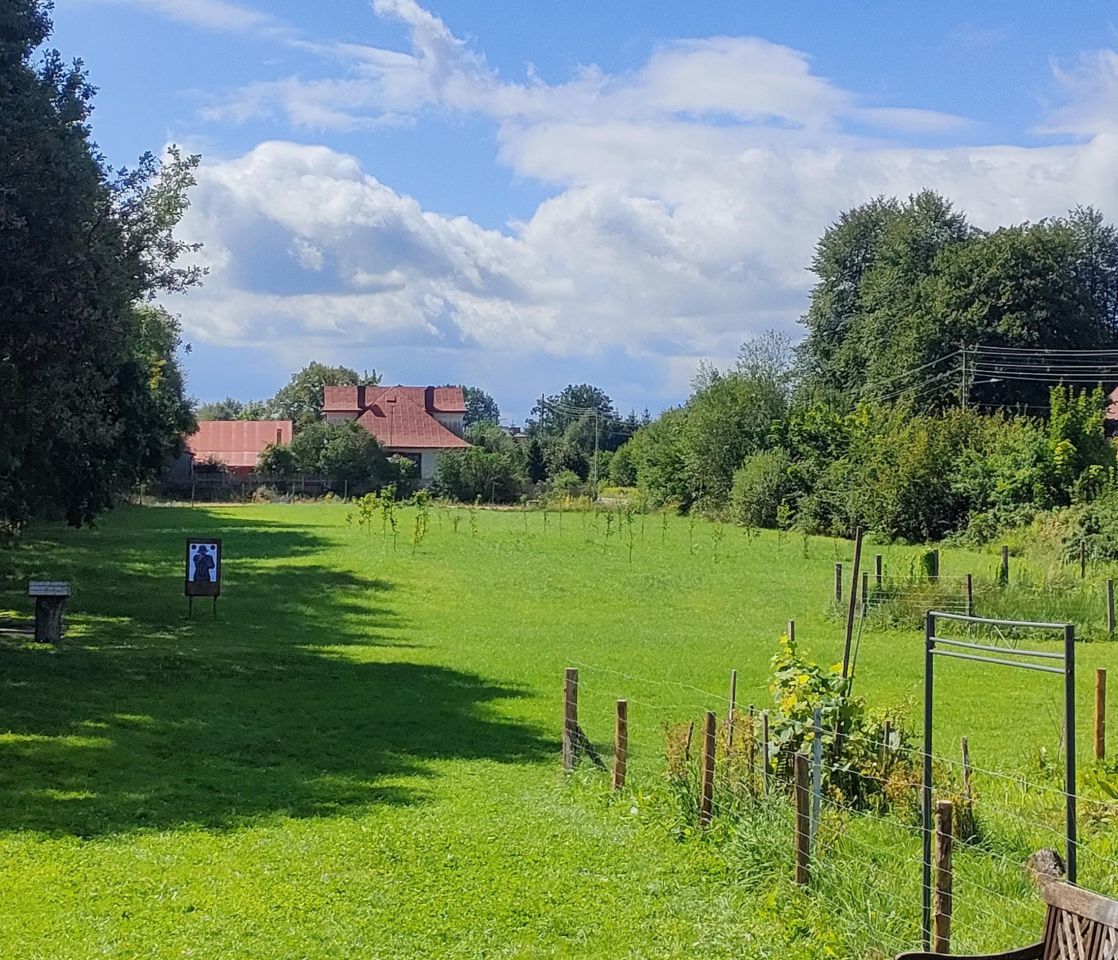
[799,191,1118,409]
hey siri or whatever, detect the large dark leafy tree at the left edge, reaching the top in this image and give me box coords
[0,0,200,525]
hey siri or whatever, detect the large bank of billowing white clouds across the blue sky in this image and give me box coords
[165,0,1118,391]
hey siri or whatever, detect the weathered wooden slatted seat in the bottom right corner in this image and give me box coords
[897,881,1118,960]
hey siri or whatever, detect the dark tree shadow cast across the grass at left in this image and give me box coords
[0,508,553,837]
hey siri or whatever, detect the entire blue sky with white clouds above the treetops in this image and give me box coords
[51,0,1118,419]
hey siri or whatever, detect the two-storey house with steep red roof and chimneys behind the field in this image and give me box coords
[322,386,470,482]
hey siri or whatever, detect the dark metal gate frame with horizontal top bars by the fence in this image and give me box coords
[920,610,1078,950]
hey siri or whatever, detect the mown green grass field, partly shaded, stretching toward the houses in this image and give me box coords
[0,504,1118,960]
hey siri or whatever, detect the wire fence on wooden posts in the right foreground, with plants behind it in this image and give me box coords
[563,663,1118,958]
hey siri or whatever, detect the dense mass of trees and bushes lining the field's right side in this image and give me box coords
[614,192,1118,540]
